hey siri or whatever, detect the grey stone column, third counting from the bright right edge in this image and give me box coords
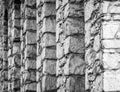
[36,0,57,92]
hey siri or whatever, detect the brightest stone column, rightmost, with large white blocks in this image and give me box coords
[85,0,120,92]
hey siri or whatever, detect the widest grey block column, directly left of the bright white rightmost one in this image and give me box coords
[56,0,86,92]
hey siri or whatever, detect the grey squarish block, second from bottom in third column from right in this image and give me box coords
[43,60,56,75]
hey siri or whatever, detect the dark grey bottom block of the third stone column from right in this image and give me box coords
[42,76,57,92]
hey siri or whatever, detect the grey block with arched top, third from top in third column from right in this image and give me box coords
[41,33,56,47]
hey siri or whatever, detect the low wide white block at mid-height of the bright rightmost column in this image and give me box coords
[102,39,120,49]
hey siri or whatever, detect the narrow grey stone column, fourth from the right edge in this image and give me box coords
[21,0,37,92]
